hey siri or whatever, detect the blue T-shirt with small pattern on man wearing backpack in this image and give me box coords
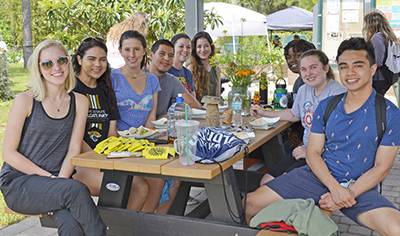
[311,90,400,182]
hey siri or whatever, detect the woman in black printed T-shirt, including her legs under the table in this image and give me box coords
[73,38,148,210]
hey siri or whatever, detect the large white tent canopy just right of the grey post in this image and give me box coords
[204,2,267,37]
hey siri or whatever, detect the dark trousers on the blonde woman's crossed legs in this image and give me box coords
[1,175,106,236]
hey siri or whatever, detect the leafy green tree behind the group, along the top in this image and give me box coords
[34,0,220,49]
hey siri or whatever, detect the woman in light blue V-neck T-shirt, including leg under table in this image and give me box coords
[111,30,165,212]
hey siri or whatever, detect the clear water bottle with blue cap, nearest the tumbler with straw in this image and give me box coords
[167,93,192,143]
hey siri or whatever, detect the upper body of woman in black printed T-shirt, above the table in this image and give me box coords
[72,38,119,152]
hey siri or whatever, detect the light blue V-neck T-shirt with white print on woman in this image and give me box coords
[111,69,161,130]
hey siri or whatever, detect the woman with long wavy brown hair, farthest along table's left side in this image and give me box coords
[188,31,221,102]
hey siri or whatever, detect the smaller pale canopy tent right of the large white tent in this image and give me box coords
[266,6,313,30]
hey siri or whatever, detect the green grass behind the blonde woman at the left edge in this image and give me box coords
[0,63,29,228]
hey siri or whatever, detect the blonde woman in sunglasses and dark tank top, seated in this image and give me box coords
[0,40,106,236]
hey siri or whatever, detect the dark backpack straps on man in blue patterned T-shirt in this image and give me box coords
[324,93,386,194]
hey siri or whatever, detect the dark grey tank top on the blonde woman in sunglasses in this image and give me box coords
[0,92,76,185]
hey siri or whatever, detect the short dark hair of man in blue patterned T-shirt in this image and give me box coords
[336,37,375,66]
